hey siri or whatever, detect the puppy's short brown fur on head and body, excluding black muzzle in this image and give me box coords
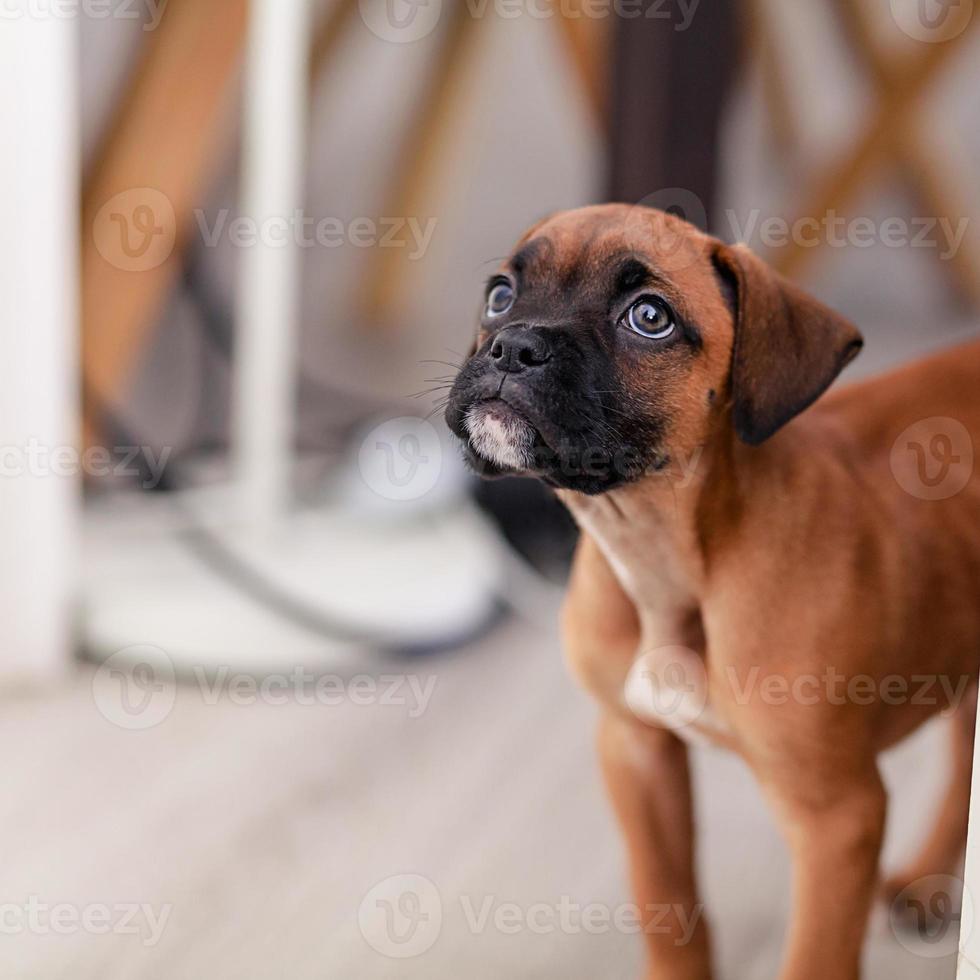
[460,206,980,980]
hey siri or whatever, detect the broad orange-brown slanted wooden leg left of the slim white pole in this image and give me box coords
[82,0,248,441]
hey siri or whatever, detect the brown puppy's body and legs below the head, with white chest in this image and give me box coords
[562,343,980,980]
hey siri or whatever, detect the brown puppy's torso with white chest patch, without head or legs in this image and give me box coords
[559,342,980,751]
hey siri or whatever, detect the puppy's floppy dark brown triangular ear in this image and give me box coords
[714,243,864,446]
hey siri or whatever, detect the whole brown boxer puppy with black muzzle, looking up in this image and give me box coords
[447,205,980,980]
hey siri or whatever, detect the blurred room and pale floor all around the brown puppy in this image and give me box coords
[0,0,980,980]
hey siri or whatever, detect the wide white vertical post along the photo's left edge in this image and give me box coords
[0,7,80,680]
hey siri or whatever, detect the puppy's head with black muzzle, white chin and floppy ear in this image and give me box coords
[446,205,862,494]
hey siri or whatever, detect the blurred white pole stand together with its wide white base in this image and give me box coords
[83,0,503,674]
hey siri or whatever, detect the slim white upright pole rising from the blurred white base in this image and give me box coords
[232,0,310,526]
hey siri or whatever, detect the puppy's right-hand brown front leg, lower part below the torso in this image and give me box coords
[768,765,885,980]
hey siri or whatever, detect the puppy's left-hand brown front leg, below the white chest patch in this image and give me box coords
[599,712,711,980]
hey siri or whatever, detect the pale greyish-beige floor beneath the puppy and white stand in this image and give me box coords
[0,610,955,980]
